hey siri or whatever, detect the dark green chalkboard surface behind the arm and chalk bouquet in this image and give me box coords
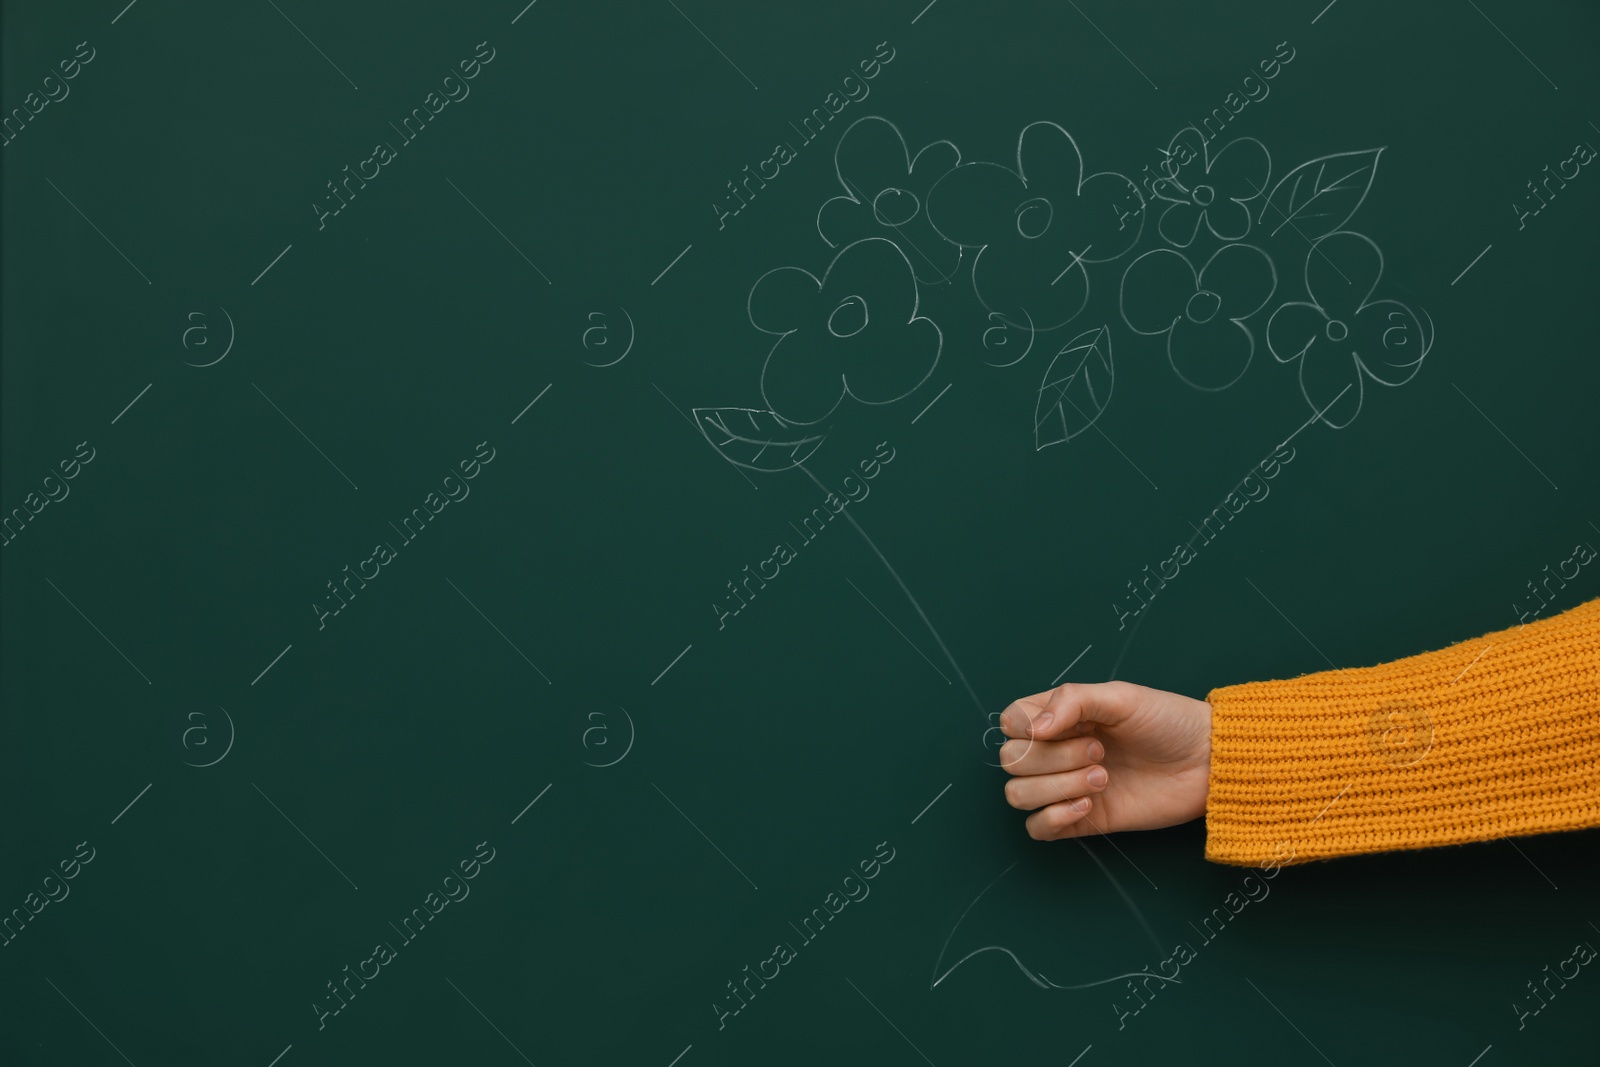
[0,0,1600,1067]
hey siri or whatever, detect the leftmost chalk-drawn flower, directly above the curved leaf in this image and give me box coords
[749,237,944,426]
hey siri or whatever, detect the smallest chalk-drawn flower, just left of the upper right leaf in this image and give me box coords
[1154,126,1272,248]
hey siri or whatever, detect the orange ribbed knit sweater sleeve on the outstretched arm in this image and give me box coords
[1205,600,1600,867]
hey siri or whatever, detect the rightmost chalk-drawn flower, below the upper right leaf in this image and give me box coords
[1267,230,1434,429]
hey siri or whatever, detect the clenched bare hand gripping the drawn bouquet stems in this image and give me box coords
[1000,681,1211,841]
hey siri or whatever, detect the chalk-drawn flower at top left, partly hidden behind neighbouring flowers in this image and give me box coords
[816,115,962,285]
